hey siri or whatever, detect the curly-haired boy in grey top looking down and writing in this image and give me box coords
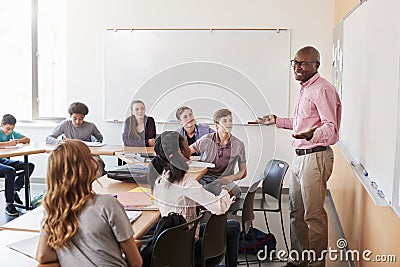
[46,102,106,175]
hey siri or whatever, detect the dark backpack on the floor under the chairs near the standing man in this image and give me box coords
[239,227,276,255]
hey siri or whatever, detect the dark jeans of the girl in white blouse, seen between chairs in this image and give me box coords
[195,220,240,267]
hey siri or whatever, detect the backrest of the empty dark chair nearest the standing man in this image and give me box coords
[262,159,289,200]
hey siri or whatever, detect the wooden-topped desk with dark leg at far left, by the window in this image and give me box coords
[0,143,46,210]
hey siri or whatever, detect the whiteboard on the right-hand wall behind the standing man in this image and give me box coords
[341,0,400,207]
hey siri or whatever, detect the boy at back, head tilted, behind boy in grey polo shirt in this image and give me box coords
[176,106,215,146]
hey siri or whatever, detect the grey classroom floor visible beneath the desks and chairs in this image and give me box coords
[0,180,351,267]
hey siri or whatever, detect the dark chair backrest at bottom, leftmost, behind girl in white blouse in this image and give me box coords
[151,216,202,267]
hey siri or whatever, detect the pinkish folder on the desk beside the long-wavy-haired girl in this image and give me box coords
[117,192,157,210]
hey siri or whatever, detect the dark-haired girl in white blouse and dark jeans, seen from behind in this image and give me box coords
[149,131,240,267]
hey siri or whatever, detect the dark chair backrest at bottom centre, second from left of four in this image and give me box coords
[201,213,227,266]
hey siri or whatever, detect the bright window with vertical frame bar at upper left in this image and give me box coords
[0,0,66,120]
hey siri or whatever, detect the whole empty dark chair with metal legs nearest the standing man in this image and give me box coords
[254,159,289,254]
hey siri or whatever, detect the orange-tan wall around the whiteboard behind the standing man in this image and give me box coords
[329,0,400,267]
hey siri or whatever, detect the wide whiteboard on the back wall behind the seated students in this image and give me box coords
[105,29,290,123]
